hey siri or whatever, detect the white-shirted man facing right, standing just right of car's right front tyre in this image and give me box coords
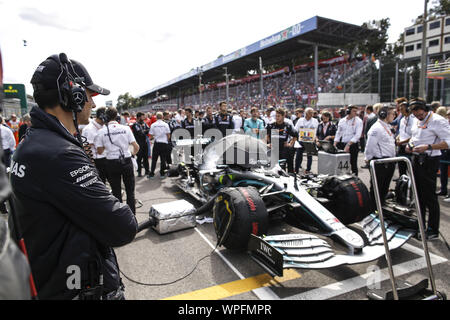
[364,107,396,209]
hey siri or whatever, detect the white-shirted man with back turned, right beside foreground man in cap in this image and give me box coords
[95,107,139,213]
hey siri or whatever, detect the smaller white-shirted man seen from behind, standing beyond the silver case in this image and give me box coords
[148,112,171,179]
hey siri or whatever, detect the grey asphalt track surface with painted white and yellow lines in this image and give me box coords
[116,154,450,300]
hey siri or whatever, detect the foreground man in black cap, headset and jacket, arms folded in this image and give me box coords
[10,54,137,299]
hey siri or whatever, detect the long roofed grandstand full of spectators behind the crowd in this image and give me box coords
[139,16,377,109]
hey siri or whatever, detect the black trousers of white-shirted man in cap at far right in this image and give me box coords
[413,157,440,232]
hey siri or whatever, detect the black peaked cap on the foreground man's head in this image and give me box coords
[31,55,110,96]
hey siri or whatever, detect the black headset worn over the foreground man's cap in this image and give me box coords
[49,53,88,113]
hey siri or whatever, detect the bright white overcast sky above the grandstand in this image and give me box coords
[0,0,436,106]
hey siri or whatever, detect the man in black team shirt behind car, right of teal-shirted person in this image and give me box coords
[267,108,297,171]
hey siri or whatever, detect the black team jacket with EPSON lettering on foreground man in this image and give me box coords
[9,107,137,299]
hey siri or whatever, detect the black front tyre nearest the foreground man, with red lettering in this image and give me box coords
[213,187,269,251]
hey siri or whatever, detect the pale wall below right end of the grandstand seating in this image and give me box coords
[317,93,380,107]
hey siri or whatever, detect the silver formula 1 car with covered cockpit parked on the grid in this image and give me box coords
[169,135,417,276]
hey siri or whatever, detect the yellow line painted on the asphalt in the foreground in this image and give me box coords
[163,270,301,300]
